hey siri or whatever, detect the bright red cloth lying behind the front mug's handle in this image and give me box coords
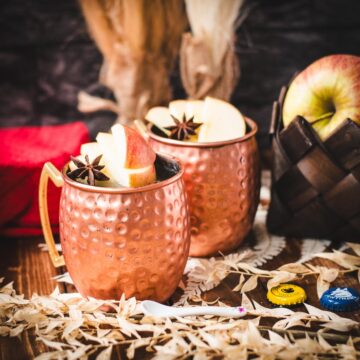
[0,122,89,236]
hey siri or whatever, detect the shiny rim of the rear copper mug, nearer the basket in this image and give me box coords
[147,116,258,148]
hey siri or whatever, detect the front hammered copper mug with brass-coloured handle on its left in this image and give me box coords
[39,156,190,302]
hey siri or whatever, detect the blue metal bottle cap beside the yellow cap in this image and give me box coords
[320,287,360,311]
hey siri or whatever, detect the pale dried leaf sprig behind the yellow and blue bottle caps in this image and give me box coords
[178,243,360,305]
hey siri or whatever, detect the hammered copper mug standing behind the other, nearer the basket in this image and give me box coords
[137,119,260,256]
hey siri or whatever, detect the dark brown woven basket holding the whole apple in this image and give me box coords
[267,87,360,242]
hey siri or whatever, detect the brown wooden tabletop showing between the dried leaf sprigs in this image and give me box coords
[0,237,360,360]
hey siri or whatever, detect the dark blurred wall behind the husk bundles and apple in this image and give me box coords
[0,0,360,146]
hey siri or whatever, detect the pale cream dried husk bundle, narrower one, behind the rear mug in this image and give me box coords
[180,0,244,100]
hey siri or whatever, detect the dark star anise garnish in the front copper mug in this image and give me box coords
[67,155,110,186]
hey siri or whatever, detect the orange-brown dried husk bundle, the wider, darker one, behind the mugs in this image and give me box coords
[79,0,187,124]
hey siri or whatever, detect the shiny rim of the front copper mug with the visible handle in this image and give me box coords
[61,153,184,194]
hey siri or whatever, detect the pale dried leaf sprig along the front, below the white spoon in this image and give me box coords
[0,279,360,360]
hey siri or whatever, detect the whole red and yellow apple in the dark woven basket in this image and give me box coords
[283,55,360,140]
